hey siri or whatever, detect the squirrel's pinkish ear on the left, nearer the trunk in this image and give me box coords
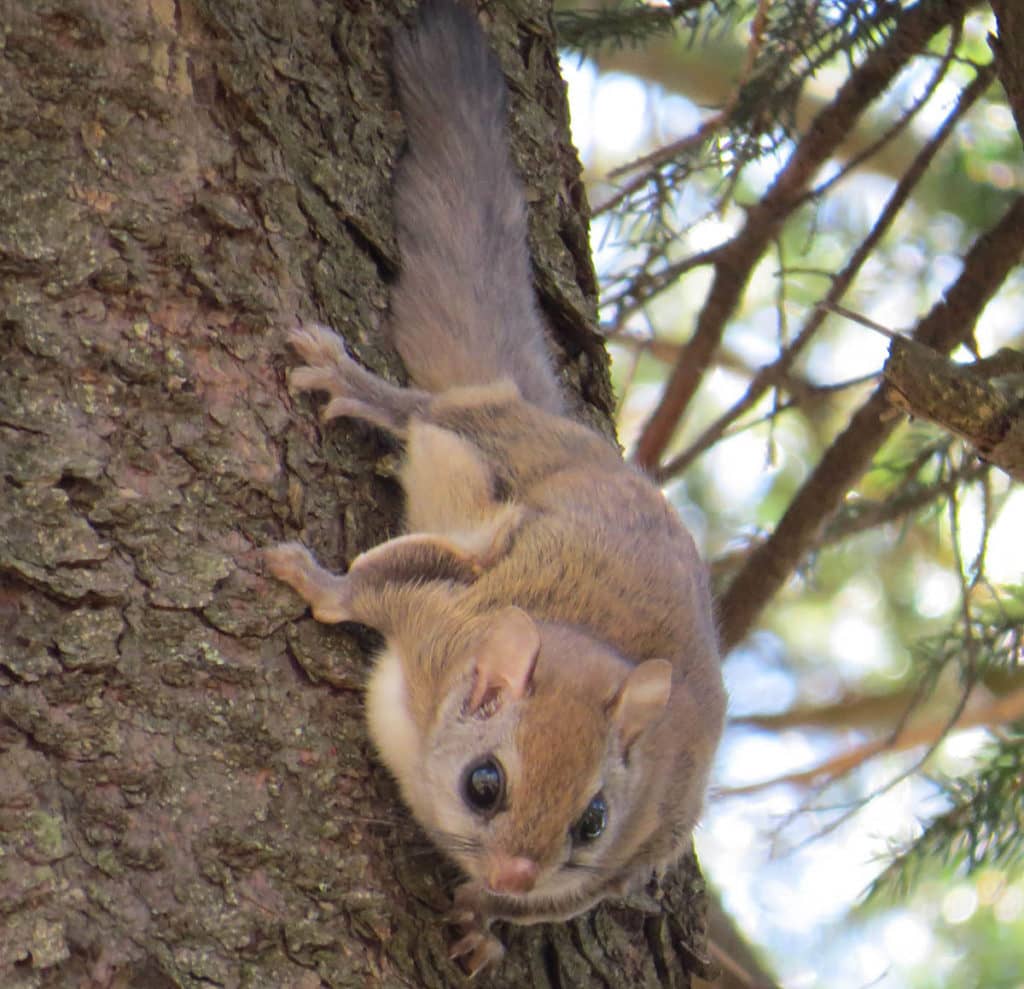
[466,608,541,713]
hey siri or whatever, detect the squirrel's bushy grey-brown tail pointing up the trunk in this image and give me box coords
[390,0,562,412]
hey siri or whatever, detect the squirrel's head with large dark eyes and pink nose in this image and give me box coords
[402,607,673,909]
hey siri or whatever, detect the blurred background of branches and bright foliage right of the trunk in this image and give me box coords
[557,0,1024,989]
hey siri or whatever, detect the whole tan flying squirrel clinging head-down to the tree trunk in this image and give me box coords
[265,0,725,974]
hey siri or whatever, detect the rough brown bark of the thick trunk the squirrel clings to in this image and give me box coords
[0,0,702,989]
